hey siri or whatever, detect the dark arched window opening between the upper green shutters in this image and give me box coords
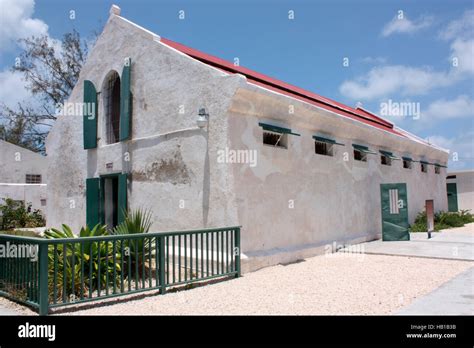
[104,71,120,144]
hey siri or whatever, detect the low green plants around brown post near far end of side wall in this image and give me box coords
[410,210,474,232]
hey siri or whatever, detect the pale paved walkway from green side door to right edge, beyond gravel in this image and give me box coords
[344,223,474,261]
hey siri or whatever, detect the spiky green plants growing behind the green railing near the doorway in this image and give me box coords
[44,210,154,301]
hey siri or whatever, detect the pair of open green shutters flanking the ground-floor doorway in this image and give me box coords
[86,174,127,228]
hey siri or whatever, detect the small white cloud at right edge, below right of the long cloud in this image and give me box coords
[421,95,474,121]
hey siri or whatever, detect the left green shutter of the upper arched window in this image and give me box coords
[82,80,98,149]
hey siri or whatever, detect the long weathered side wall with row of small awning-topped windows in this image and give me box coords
[229,86,448,264]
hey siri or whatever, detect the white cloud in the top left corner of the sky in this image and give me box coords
[0,0,48,50]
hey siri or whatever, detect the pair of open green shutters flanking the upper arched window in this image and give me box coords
[83,58,132,149]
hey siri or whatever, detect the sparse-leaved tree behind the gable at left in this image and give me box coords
[0,30,88,153]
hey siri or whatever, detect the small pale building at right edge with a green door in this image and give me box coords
[446,169,474,214]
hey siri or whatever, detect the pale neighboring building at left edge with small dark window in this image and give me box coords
[0,140,48,216]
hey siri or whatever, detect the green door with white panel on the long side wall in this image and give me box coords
[380,184,410,241]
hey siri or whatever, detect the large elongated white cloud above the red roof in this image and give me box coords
[339,65,455,100]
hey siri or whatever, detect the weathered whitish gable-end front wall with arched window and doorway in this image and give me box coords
[47,12,243,230]
